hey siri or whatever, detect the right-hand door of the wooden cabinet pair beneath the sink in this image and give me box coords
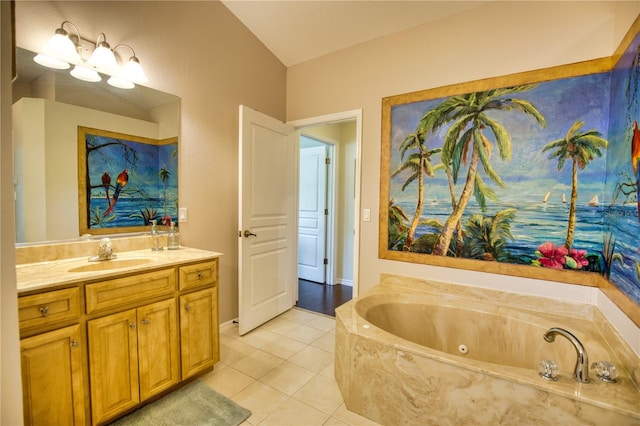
[138,299,180,401]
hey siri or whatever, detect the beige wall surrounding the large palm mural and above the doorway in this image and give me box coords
[287,1,640,342]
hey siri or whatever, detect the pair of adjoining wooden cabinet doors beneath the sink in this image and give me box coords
[87,299,180,423]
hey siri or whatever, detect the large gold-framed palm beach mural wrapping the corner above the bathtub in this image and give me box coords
[379,20,640,322]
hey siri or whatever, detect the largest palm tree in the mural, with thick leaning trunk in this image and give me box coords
[418,85,546,256]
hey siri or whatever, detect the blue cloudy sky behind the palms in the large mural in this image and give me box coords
[390,73,610,204]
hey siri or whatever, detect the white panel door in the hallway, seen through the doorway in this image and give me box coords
[298,146,327,283]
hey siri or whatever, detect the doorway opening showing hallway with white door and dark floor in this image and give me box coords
[296,114,359,316]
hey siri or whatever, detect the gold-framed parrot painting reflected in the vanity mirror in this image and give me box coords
[78,126,178,235]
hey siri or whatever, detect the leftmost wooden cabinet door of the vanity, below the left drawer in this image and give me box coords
[20,325,85,425]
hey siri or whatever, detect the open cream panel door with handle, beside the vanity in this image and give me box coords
[238,105,298,334]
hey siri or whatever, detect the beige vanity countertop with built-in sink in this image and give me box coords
[16,247,222,294]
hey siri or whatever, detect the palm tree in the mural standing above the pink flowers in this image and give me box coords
[542,120,608,250]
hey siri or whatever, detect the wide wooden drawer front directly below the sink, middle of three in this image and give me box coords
[85,269,176,314]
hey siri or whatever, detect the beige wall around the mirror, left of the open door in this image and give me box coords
[11,1,286,321]
